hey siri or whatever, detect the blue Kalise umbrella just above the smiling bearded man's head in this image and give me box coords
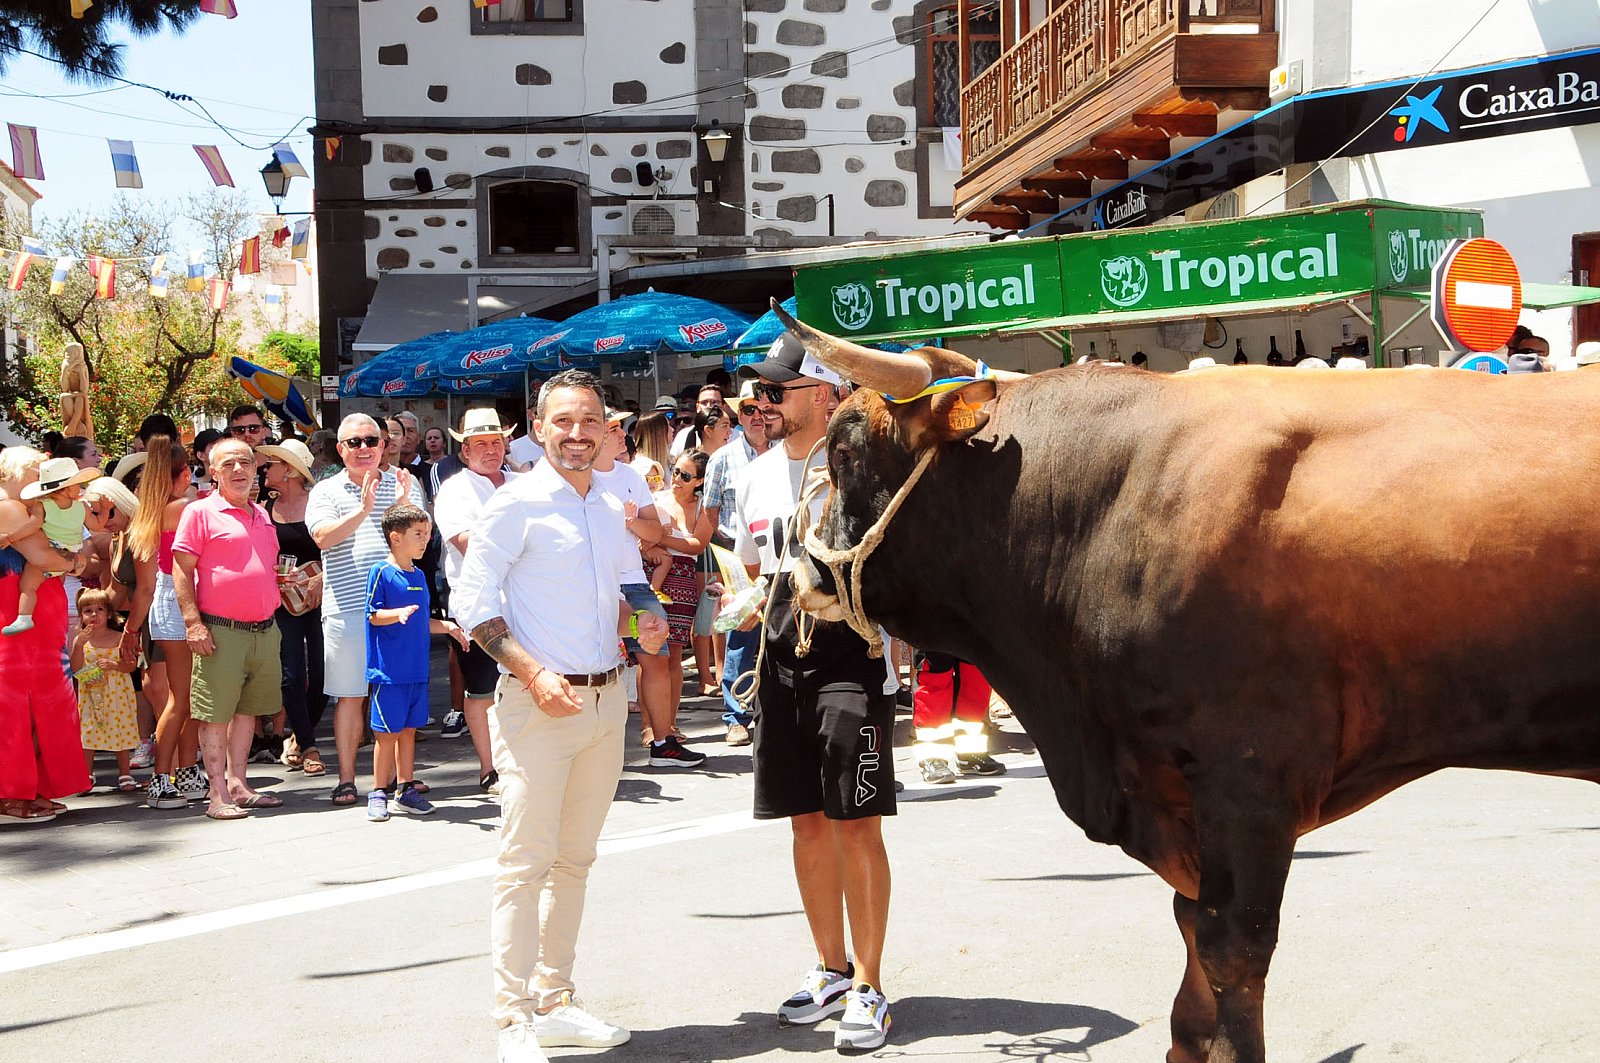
[528,291,752,368]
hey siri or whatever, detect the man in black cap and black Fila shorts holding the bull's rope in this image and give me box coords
[734,335,898,1050]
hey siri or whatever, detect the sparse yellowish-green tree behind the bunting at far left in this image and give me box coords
[0,191,294,451]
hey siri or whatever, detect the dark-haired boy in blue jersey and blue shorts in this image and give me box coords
[366,503,467,823]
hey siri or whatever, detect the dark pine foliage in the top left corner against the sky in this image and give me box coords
[0,0,204,82]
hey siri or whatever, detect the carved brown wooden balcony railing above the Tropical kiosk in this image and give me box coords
[962,0,1272,168]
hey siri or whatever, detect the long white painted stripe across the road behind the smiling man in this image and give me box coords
[0,812,771,975]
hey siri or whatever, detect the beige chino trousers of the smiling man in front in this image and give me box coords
[490,676,627,1026]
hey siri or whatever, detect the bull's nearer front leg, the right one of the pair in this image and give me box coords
[1195,794,1294,1063]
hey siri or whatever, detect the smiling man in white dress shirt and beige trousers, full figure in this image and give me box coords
[451,370,667,1063]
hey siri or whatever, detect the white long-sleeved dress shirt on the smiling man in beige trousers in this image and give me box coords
[450,461,637,674]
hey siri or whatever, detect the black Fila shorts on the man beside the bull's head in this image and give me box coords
[752,668,894,820]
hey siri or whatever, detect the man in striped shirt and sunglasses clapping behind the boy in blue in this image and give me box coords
[306,413,424,805]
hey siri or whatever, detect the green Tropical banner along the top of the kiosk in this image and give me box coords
[795,200,1483,336]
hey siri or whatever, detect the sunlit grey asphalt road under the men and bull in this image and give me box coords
[0,669,1600,1063]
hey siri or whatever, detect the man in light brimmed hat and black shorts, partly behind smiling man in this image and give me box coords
[434,407,517,794]
